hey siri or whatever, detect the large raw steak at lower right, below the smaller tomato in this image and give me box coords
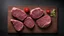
[36,15,51,28]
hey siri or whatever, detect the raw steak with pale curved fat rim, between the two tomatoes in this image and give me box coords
[30,7,43,19]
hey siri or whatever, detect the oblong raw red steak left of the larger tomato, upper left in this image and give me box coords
[11,7,27,21]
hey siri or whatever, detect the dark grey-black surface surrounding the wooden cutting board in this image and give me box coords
[0,0,64,36]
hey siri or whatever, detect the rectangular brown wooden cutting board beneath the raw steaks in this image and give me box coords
[8,6,58,33]
